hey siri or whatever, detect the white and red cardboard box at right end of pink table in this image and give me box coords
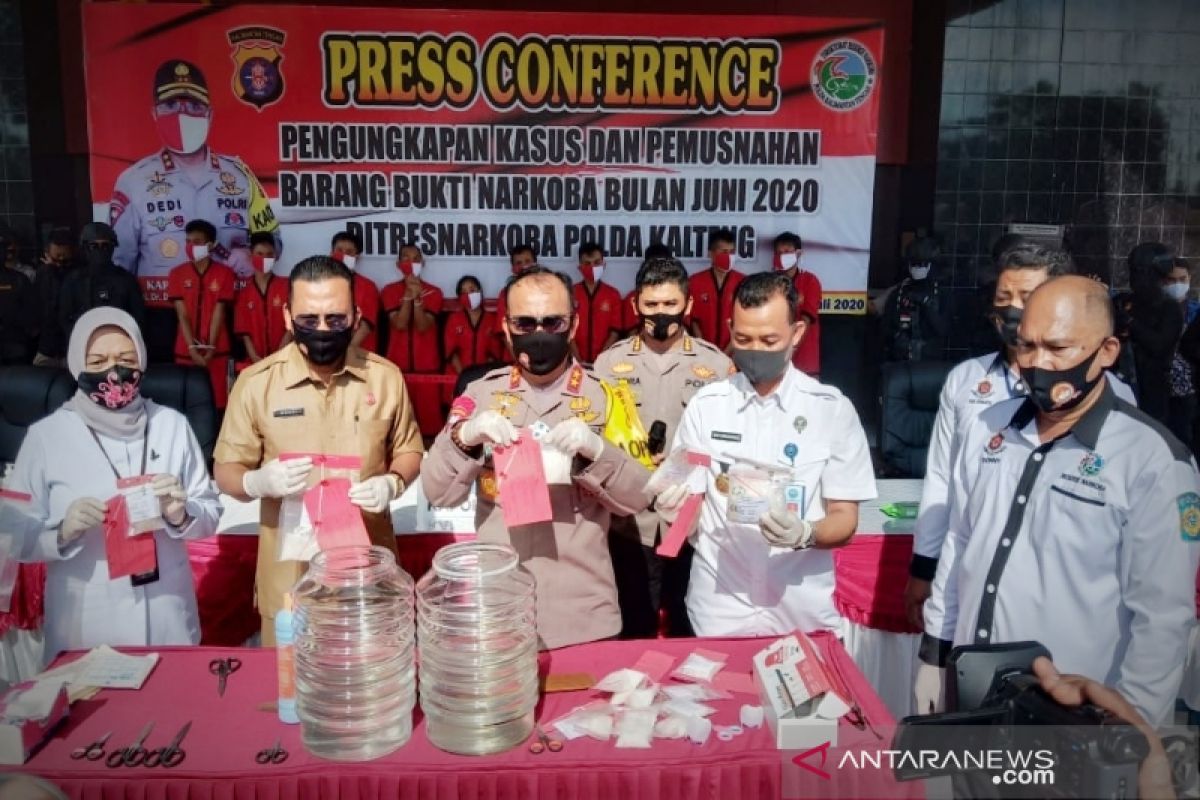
[754,632,850,750]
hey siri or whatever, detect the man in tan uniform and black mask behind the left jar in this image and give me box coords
[215,255,422,645]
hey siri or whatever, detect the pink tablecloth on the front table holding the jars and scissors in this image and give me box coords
[25,636,916,800]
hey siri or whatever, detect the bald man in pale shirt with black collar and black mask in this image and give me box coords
[914,276,1200,726]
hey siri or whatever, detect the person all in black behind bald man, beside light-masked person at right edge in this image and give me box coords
[1116,242,1183,425]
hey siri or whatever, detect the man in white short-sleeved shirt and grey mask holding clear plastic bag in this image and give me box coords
[656,272,875,636]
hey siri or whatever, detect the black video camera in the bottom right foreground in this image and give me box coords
[893,642,1150,798]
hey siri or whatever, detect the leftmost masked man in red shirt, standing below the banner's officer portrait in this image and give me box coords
[167,219,234,409]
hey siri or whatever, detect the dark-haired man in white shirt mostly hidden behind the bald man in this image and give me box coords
[905,237,1136,627]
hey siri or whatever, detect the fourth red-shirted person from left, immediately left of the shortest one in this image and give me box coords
[383,245,445,437]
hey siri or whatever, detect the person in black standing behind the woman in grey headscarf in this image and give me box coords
[59,222,145,338]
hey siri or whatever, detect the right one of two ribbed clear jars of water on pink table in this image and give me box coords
[416,542,538,756]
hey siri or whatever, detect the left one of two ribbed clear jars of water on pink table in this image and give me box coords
[293,547,416,762]
